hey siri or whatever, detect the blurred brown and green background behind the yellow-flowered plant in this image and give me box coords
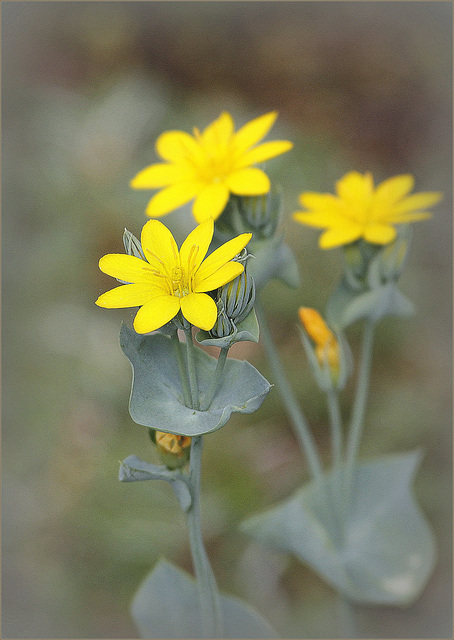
[2,1,452,638]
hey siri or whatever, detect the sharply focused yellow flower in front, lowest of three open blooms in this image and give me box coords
[96,218,252,333]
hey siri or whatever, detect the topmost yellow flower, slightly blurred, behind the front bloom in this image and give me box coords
[130,111,293,222]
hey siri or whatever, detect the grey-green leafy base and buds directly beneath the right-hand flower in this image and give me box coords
[326,225,414,331]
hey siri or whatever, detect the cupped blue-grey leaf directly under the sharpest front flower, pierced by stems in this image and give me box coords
[120,325,271,436]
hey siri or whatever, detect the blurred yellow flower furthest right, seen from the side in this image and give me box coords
[293,171,441,249]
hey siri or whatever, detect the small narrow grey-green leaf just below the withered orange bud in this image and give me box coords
[118,456,192,511]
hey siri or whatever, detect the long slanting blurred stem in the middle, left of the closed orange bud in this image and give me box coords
[255,301,323,482]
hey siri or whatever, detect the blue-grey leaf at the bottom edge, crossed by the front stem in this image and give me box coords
[131,560,277,639]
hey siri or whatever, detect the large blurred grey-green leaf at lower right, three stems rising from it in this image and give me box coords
[242,452,435,606]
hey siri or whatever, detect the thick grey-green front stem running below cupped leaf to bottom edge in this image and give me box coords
[187,436,223,638]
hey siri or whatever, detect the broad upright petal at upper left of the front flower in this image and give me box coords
[140,220,180,277]
